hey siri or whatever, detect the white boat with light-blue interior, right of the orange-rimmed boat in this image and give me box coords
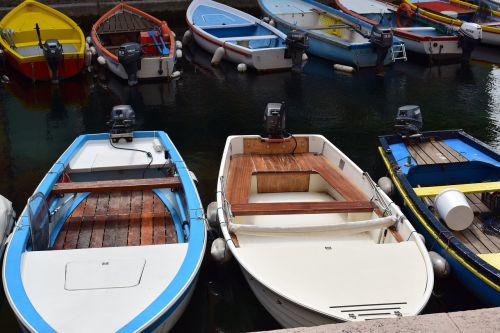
[186,0,298,71]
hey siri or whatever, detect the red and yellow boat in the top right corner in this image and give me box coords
[403,0,500,46]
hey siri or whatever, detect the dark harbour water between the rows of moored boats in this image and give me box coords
[0,24,500,332]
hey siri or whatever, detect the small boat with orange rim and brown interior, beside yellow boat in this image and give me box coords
[91,2,177,85]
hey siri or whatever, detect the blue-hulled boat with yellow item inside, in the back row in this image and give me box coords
[258,0,406,68]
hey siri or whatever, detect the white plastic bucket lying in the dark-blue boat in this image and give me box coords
[434,188,474,231]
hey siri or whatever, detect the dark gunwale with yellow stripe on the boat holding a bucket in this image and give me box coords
[379,129,500,291]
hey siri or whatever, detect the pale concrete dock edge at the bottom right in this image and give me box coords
[258,308,500,333]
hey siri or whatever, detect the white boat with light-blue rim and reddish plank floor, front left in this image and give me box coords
[3,109,206,332]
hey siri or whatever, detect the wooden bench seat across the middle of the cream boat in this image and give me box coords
[231,201,375,216]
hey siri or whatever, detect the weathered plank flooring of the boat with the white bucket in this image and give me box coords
[406,139,500,254]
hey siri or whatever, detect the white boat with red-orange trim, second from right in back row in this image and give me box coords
[335,0,482,61]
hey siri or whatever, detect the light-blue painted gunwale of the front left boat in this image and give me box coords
[2,131,206,332]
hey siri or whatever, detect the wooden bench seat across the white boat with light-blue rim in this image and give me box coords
[52,177,182,194]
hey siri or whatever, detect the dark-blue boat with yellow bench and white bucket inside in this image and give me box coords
[379,108,500,306]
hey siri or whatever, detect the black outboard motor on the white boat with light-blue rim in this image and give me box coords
[107,105,135,142]
